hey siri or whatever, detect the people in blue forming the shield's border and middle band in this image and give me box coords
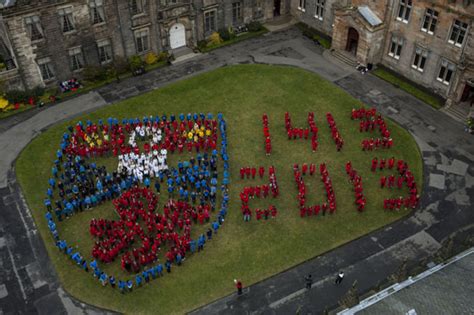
[44,113,229,293]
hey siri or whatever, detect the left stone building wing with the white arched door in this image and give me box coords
[0,0,278,89]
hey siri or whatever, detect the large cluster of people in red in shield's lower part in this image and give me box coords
[90,187,206,272]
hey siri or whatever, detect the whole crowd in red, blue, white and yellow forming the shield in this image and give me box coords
[44,114,229,292]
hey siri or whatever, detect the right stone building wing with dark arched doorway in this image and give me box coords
[291,0,474,105]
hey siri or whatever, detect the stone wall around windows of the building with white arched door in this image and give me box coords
[0,0,260,88]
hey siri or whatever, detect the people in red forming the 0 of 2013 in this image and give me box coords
[293,163,336,217]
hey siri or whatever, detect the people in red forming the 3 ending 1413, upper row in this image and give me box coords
[351,108,393,151]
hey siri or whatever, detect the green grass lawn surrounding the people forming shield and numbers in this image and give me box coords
[16,65,422,314]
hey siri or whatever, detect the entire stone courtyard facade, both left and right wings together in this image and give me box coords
[0,0,474,105]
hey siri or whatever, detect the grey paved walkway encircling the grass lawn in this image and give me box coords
[0,29,474,314]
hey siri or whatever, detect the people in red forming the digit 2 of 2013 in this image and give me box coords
[240,166,280,221]
